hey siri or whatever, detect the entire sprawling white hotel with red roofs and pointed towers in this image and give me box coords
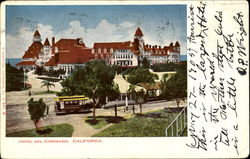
[16,27,180,76]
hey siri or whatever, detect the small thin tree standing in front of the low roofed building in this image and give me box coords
[128,85,145,114]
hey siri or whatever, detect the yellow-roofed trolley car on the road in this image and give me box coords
[54,95,90,114]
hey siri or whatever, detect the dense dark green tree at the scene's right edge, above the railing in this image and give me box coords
[161,70,187,107]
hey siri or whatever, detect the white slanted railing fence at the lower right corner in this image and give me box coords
[165,106,187,136]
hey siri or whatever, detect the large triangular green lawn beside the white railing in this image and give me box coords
[94,109,185,137]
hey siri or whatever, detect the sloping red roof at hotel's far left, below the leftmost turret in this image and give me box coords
[23,42,43,58]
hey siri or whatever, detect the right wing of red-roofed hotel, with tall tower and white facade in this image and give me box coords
[91,27,180,67]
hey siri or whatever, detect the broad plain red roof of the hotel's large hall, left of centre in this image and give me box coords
[58,47,91,64]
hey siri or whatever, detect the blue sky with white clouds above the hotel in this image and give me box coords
[6,5,187,58]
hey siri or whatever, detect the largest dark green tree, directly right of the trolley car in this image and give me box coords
[59,60,115,120]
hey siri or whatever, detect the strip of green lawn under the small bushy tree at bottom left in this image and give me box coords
[7,124,74,137]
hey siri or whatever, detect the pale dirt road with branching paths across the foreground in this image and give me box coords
[6,73,185,137]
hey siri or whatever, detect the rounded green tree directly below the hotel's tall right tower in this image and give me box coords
[128,67,159,100]
